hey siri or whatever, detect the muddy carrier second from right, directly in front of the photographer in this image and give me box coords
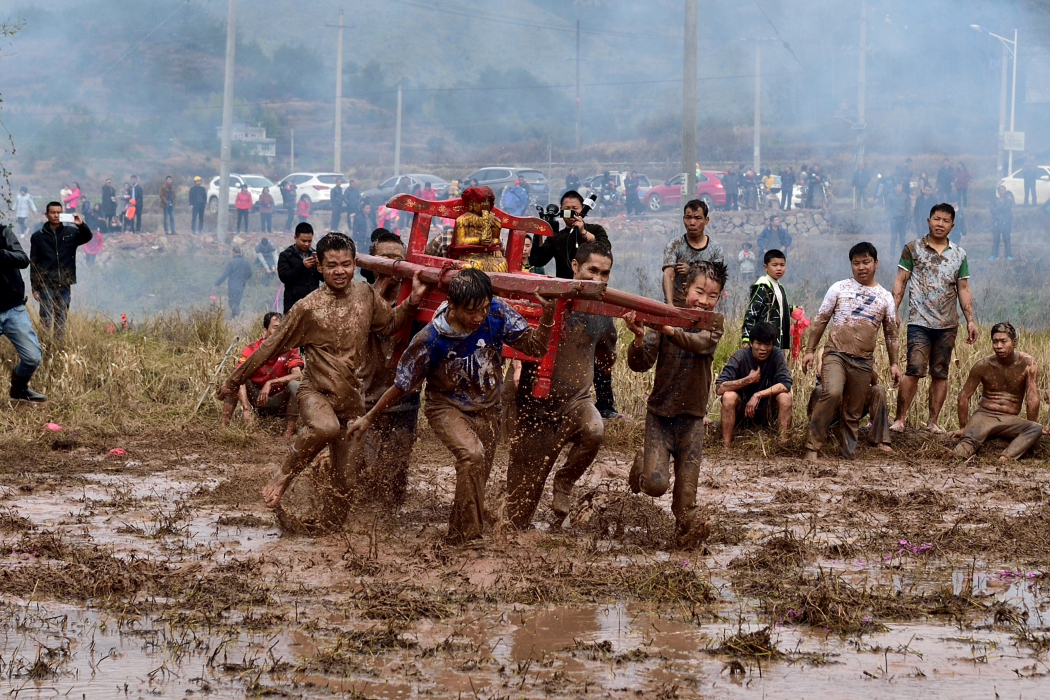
[507,240,617,528]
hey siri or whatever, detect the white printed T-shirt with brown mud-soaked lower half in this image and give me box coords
[806,277,897,360]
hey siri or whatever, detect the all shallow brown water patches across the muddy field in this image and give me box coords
[0,457,1050,700]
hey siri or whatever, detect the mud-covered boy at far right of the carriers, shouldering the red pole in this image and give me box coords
[624,260,726,548]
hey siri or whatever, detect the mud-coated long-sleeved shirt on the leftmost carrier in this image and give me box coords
[230,282,417,420]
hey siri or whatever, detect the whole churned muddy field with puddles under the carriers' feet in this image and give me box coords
[0,421,1050,699]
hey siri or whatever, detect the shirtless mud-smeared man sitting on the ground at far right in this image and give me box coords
[952,323,1043,462]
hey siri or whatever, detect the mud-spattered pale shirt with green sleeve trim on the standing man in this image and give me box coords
[899,236,970,328]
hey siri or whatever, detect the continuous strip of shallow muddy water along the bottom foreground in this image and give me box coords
[0,603,1050,700]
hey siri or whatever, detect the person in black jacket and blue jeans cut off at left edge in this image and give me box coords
[0,226,45,401]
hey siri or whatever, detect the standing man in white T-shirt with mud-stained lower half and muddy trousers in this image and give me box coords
[802,241,901,462]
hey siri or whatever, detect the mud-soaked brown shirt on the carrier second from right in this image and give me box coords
[518,313,617,406]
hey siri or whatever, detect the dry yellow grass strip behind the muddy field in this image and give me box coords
[6,306,1050,459]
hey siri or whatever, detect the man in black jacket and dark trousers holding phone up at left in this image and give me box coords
[29,201,95,341]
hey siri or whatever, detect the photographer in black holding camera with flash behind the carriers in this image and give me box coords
[529,190,620,419]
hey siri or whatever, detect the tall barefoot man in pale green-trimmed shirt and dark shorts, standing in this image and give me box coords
[889,204,978,433]
